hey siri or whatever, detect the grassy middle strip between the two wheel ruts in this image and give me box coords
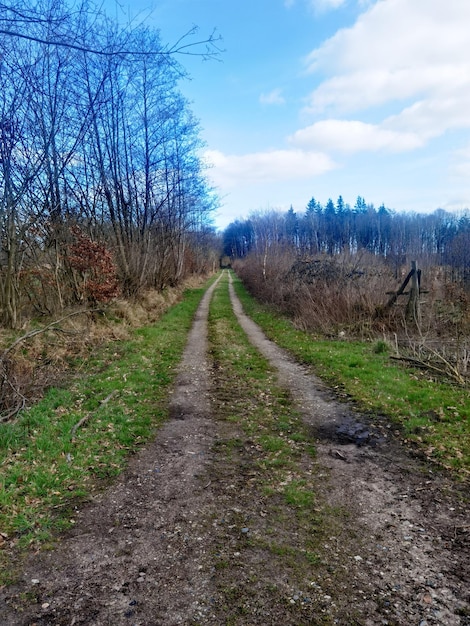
[209,272,360,625]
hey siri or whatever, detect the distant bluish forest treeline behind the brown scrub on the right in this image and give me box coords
[224,196,470,271]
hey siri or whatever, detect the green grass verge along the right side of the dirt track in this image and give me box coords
[234,277,470,478]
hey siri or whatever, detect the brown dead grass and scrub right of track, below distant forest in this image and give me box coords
[234,247,470,384]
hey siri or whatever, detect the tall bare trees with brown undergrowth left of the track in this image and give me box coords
[0,0,218,327]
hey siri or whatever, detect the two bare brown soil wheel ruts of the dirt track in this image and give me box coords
[0,274,470,626]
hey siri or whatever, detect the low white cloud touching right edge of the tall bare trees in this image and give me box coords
[205,149,336,189]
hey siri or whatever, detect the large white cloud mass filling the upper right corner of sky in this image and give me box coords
[302,0,470,151]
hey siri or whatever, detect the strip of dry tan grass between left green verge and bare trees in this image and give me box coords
[0,276,207,421]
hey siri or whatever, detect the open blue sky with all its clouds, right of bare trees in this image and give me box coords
[107,0,470,228]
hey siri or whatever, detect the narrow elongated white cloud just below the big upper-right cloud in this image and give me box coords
[289,120,424,153]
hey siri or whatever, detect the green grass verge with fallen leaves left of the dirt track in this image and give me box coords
[0,278,213,583]
